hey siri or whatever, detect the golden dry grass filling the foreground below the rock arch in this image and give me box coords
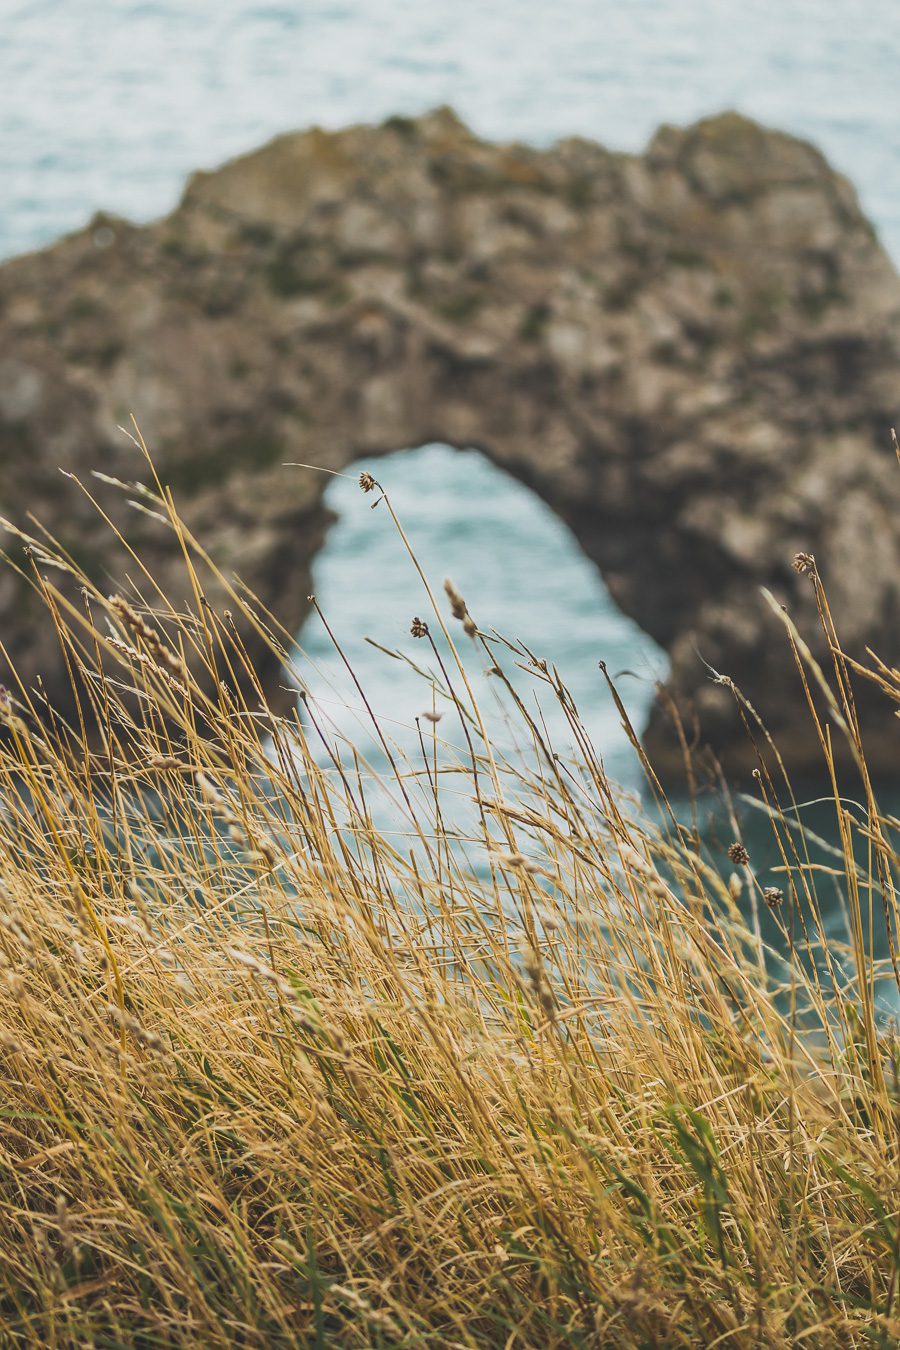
[0,450,900,1347]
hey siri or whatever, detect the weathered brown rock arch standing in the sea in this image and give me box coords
[0,111,900,768]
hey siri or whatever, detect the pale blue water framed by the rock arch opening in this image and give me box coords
[300,443,668,783]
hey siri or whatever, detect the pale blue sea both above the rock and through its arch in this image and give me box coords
[0,0,900,782]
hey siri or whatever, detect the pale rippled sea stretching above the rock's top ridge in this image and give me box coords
[0,0,900,257]
